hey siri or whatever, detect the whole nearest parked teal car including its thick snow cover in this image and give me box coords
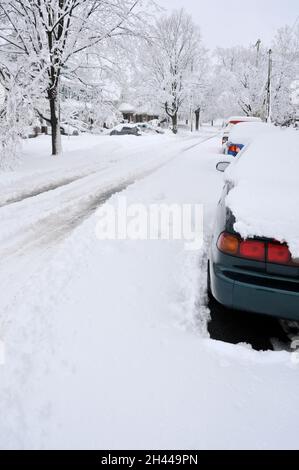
[208,130,299,321]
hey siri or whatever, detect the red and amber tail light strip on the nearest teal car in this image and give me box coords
[217,232,299,266]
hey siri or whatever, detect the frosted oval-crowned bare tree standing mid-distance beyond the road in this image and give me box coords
[143,10,202,133]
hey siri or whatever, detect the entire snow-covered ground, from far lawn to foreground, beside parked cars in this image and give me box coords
[0,129,299,449]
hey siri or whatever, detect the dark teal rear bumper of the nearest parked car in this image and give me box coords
[210,261,299,320]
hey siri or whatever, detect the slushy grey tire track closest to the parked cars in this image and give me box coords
[0,147,190,316]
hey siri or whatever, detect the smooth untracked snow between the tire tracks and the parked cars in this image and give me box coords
[0,134,299,449]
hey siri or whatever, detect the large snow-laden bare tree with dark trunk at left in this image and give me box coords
[0,0,144,155]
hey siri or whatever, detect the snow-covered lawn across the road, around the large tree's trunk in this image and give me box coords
[0,134,175,206]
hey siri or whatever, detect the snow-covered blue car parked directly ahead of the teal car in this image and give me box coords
[224,122,278,157]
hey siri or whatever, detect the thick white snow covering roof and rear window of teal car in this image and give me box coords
[225,129,299,258]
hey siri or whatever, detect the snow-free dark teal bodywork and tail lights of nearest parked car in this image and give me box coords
[208,163,299,320]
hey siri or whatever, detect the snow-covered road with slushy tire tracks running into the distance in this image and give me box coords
[0,131,215,314]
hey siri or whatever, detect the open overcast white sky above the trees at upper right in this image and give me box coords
[158,0,299,48]
